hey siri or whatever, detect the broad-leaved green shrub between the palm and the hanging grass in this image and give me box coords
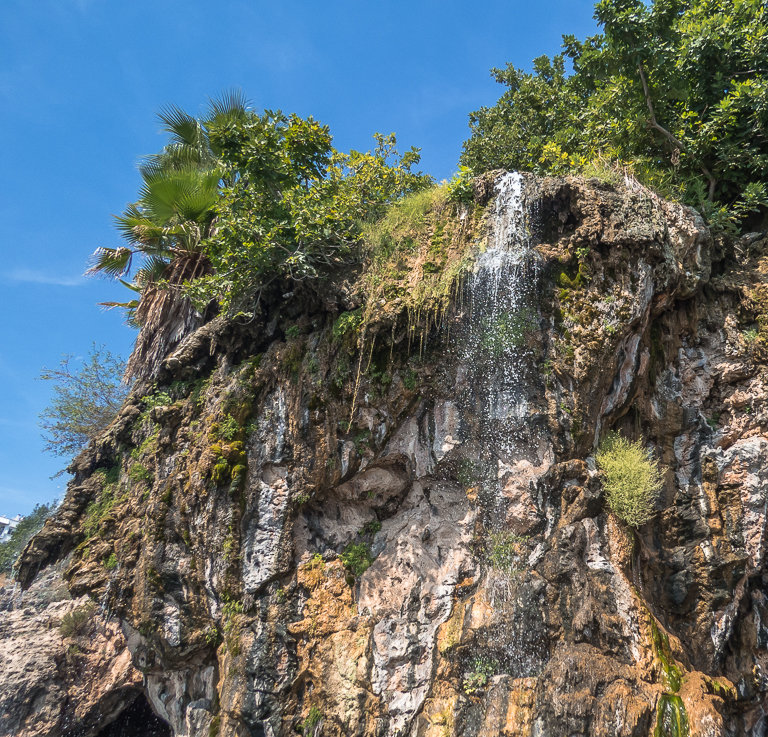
[188,115,431,312]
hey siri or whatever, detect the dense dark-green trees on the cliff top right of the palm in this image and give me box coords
[462,0,768,230]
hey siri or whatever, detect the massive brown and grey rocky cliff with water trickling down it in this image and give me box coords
[6,173,768,737]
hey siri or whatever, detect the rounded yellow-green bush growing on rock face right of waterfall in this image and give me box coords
[595,433,663,527]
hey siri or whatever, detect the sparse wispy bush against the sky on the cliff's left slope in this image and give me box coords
[39,343,129,457]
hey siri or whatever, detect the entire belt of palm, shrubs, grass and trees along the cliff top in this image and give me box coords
[85,0,768,388]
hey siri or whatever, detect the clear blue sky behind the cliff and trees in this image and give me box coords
[0,0,595,515]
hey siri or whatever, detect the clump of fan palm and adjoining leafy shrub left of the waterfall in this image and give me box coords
[91,93,432,332]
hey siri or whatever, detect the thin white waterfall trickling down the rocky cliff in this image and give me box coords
[457,173,544,676]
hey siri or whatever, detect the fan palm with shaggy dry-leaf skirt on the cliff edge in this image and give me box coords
[86,93,247,379]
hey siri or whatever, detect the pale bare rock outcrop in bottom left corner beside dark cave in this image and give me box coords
[0,566,142,735]
